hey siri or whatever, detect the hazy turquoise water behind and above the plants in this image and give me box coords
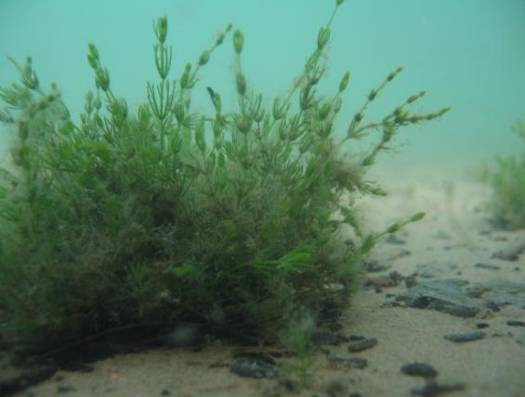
[0,0,525,171]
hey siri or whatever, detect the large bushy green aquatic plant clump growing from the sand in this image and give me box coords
[0,0,447,349]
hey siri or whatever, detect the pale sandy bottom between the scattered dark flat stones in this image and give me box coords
[11,172,525,397]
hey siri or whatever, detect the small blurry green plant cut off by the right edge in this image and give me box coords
[481,121,525,228]
